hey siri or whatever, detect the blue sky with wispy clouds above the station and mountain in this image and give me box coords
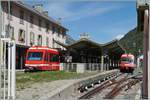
[25,0,137,43]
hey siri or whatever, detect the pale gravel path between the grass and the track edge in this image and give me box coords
[16,71,99,100]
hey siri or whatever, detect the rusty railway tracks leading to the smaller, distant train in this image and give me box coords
[79,74,141,99]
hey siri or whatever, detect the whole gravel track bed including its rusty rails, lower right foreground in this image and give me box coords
[49,69,141,100]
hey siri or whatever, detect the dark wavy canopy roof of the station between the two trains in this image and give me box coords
[55,38,124,63]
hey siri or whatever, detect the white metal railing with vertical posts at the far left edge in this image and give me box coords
[0,39,16,100]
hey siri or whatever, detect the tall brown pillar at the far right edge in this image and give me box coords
[143,1,150,99]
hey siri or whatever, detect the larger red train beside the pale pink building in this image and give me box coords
[25,46,60,71]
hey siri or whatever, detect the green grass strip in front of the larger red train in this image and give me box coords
[16,71,84,90]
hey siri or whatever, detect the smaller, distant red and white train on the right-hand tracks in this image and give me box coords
[119,54,136,73]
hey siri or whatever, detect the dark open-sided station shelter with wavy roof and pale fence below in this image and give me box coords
[55,38,125,73]
